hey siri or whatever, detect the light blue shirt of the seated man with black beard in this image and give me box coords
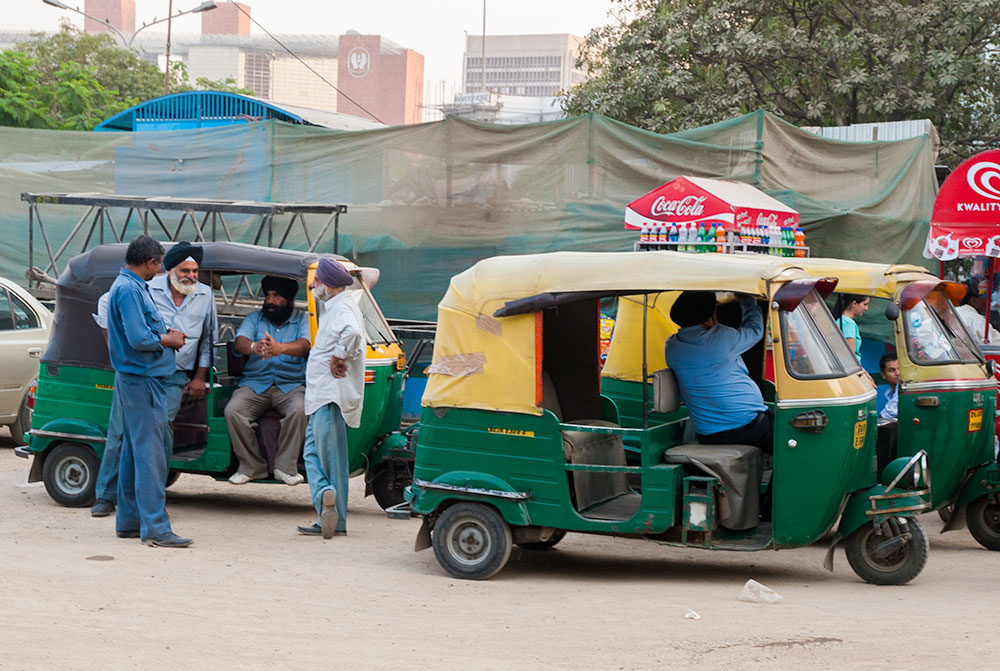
[236,308,309,394]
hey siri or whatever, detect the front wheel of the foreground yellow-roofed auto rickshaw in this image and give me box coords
[844,517,930,585]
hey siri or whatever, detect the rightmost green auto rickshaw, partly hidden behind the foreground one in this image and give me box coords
[798,258,1000,550]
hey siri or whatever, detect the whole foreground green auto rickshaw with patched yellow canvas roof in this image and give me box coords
[404,252,929,584]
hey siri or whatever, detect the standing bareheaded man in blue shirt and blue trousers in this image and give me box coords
[108,235,192,547]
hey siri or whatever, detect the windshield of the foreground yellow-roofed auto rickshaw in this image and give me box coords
[780,291,861,380]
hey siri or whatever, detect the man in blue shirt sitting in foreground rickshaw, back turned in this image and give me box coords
[664,291,774,454]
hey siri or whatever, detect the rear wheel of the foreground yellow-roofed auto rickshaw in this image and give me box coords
[432,501,513,580]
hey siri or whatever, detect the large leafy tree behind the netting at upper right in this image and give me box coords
[563,0,1000,160]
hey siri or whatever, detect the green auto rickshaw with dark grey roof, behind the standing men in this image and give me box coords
[17,242,413,507]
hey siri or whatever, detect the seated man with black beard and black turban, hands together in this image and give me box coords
[226,276,309,485]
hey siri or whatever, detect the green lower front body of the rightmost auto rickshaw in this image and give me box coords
[896,389,997,510]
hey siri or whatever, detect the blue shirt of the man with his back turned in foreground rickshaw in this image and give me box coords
[664,297,767,436]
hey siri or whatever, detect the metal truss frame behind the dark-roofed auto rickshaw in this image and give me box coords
[21,193,347,295]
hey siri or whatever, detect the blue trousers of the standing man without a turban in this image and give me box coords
[112,373,170,539]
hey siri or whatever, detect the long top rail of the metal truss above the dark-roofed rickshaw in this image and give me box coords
[21,193,347,215]
